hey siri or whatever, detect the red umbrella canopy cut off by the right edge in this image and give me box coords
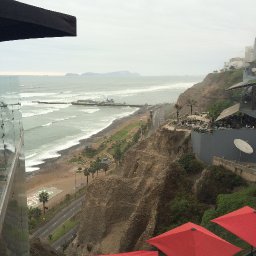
[212,206,256,247]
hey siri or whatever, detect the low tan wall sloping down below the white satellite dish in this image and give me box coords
[213,157,256,182]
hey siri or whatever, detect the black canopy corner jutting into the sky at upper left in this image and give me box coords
[0,0,76,42]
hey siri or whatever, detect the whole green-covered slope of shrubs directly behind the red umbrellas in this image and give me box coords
[155,154,250,253]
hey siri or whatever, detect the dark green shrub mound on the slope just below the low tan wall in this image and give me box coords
[197,166,246,204]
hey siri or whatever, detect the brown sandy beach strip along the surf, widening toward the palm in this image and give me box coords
[26,109,148,207]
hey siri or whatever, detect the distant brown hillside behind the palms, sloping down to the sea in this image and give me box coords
[177,70,243,113]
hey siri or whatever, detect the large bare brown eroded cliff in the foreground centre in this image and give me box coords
[70,130,190,255]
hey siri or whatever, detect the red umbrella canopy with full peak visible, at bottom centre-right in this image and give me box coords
[147,222,241,256]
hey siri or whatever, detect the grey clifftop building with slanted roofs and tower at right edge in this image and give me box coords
[191,38,256,164]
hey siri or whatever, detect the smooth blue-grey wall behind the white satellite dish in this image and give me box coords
[191,128,256,164]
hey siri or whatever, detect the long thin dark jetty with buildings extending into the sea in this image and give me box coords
[33,100,149,108]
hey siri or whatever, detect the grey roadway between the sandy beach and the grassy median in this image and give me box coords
[30,196,84,239]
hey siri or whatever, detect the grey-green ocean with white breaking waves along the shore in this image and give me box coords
[0,76,201,172]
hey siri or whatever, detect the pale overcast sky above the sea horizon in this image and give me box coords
[0,0,256,75]
